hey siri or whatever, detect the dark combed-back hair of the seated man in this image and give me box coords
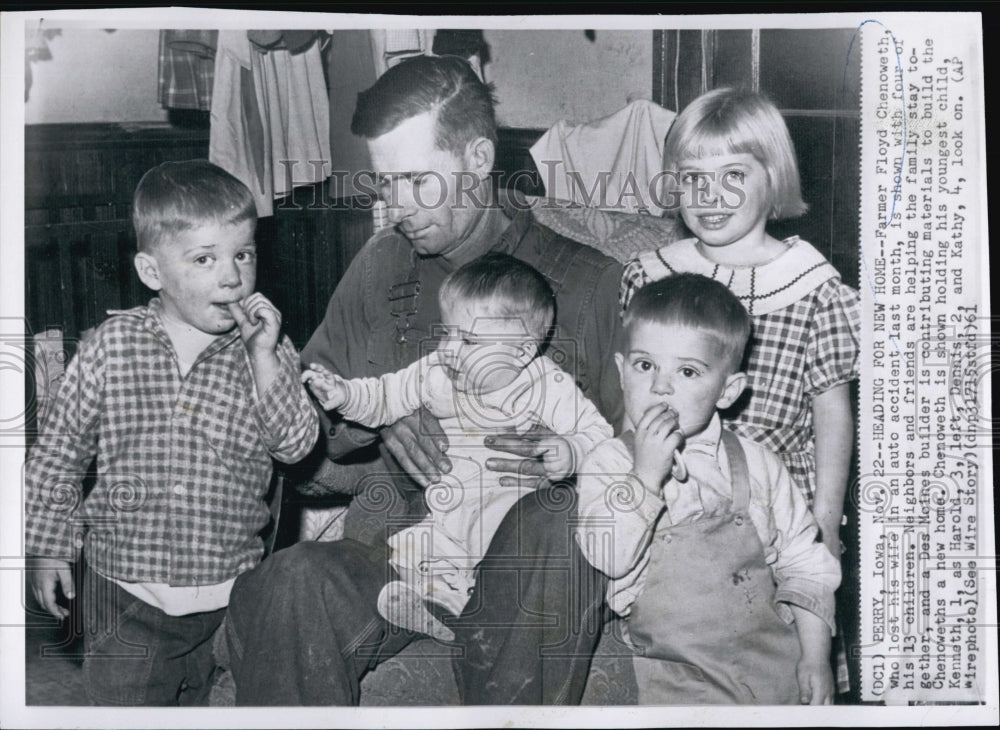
[351,56,497,157]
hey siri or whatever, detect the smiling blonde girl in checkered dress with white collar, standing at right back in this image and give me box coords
[621,88,860,559]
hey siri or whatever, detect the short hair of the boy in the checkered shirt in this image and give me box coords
[132,160,257,252]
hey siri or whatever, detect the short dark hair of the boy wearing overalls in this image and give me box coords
[622,274,752,372]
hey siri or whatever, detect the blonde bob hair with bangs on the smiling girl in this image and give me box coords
[663,87,808,220]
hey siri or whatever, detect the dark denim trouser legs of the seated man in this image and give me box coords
[226,487,607,705]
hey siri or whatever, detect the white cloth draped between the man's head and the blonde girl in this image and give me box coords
[531,100,677,215]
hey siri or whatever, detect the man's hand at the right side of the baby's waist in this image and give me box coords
[484,424,577,489]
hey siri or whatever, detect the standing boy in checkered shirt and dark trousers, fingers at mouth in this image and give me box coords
[25,160,318,705]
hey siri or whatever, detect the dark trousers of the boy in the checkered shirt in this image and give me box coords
[83,569,226,706]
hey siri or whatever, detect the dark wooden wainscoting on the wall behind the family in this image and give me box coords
[25,124,543,349]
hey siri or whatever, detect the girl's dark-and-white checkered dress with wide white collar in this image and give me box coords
[621,238,861,506]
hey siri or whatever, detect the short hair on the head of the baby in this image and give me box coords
[438,253,556,345]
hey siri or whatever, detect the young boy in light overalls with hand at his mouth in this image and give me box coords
[577,274,840,704]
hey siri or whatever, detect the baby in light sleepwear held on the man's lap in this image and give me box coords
[302,253,613,640]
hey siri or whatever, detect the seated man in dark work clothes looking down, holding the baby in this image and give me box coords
[227,57,622,705]
